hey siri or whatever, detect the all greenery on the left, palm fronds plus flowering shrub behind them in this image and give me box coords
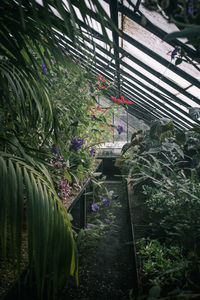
[0,0,117,298]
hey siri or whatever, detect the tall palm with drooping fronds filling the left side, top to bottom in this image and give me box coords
[0,0,115,298]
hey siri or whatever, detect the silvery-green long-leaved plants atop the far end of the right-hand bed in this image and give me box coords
[122,119,200,186]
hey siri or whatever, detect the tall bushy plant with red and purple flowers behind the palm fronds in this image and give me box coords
[36,57,118,201]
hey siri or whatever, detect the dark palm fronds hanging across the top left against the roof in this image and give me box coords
[0,0,114,73]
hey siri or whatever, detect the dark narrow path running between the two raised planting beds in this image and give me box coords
[57,181,137,300]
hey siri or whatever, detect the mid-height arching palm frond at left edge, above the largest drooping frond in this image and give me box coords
[0,59,53,132]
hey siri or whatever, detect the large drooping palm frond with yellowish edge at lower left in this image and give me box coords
[0,152,77,298]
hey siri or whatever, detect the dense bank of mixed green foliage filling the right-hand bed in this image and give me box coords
[119,120,200,299]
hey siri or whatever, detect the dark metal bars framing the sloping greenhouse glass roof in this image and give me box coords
[55,0,200,129]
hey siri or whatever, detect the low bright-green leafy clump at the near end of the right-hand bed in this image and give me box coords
[136,238,188,288]
